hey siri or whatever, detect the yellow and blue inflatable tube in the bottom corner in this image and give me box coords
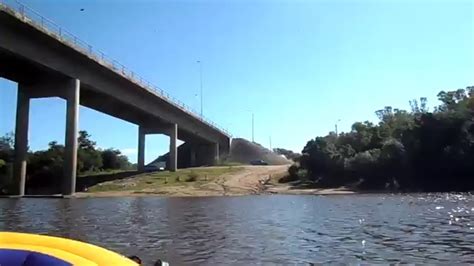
[0,232,138,266]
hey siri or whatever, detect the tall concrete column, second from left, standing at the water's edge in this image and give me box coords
[62,79,80,195]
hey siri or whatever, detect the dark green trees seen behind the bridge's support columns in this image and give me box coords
[0,131,134,193]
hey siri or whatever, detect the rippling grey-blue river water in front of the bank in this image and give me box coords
[0,194,474,265]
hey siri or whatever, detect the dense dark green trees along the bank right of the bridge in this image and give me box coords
[289,86,474,191]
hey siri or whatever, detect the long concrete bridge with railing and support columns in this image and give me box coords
[0,0,230,196]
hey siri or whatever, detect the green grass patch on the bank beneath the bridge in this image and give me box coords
[89,166,243,192]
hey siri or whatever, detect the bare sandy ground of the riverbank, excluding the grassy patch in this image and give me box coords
[77,165,354,197]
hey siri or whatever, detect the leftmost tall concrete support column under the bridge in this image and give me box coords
[13,84,30,196]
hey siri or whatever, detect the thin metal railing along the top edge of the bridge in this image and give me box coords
[0,0,231,136]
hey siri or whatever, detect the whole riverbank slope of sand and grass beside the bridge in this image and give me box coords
[77,165,354,197]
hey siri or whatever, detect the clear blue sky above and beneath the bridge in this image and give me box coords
[0,0,474,161]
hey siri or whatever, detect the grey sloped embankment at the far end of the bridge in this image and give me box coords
[228,138,291,165]
